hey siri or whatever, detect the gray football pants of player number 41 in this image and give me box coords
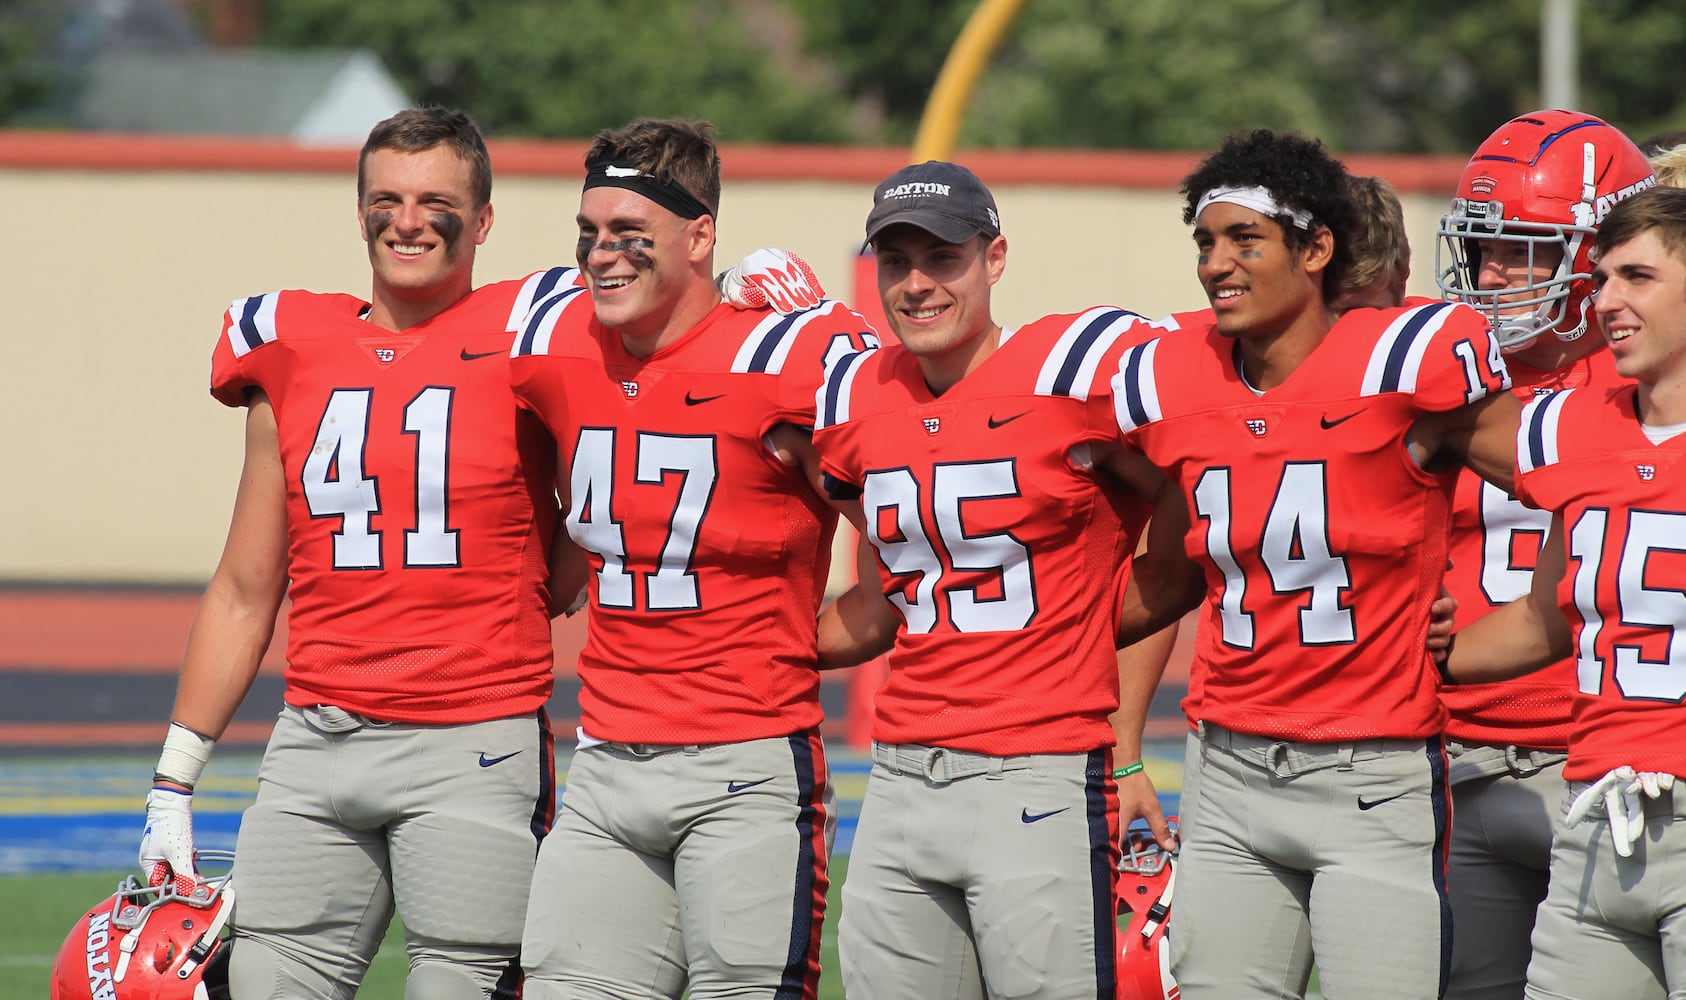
[229,707,555,1000]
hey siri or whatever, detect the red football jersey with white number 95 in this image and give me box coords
[814,309,1163,755]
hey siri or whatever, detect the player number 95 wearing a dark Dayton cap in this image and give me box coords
[814,160,1172,998]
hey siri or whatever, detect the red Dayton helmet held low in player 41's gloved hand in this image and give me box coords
[49,850,234,1000]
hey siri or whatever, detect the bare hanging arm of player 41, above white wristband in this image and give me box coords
[172,390,287,739]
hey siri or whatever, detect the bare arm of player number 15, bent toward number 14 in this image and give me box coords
[1443,514,1575,685]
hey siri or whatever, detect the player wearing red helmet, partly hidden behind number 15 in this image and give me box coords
[1435,110,1652,1000]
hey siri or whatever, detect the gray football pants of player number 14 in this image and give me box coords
[1170,723,1452,1000]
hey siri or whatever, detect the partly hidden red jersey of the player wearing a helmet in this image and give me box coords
[1440,347,1622,750]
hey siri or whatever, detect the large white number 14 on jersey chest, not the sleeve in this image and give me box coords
[1194,462,1357,649]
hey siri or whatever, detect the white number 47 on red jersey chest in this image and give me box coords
[568,427,718,610]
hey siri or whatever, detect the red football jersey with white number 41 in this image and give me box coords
[211,268,577,723]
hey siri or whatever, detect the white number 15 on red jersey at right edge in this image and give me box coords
[1568,508,1686,702]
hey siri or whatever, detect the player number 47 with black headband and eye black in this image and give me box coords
[509,120,875,998]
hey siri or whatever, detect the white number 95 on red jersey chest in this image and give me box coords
[862,460,1037,634]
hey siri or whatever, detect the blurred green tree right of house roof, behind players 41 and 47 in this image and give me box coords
[263,0,850,142]
